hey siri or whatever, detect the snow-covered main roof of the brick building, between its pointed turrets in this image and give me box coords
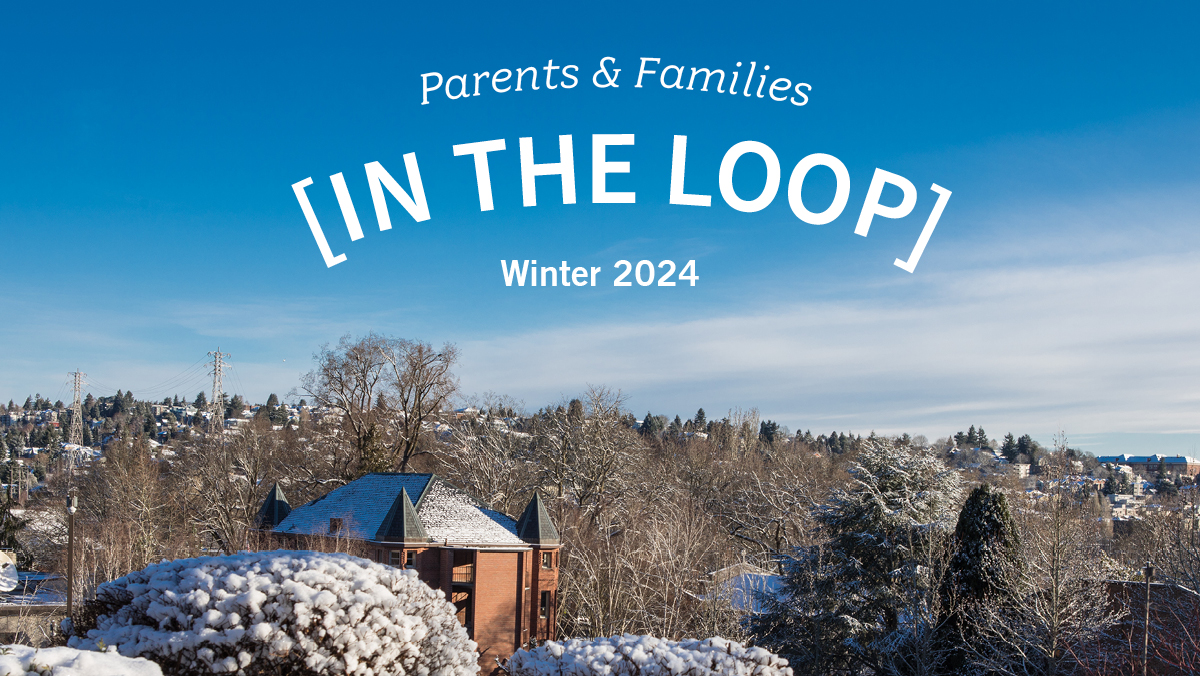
[274,474,526,546]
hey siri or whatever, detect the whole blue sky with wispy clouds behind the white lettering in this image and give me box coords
[0,2,1200,453]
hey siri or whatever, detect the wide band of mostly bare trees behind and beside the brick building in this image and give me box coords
[9,334,1200,675]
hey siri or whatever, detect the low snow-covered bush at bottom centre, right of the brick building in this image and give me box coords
[508,634,792,676]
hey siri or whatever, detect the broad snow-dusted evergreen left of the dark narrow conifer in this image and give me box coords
[749,438,962,674]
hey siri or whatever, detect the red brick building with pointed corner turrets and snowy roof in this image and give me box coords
[259,474,559,674]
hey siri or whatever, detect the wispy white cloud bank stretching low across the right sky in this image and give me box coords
[463,200,1200,435]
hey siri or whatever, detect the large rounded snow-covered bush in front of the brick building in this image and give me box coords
[70,551,479,676]
